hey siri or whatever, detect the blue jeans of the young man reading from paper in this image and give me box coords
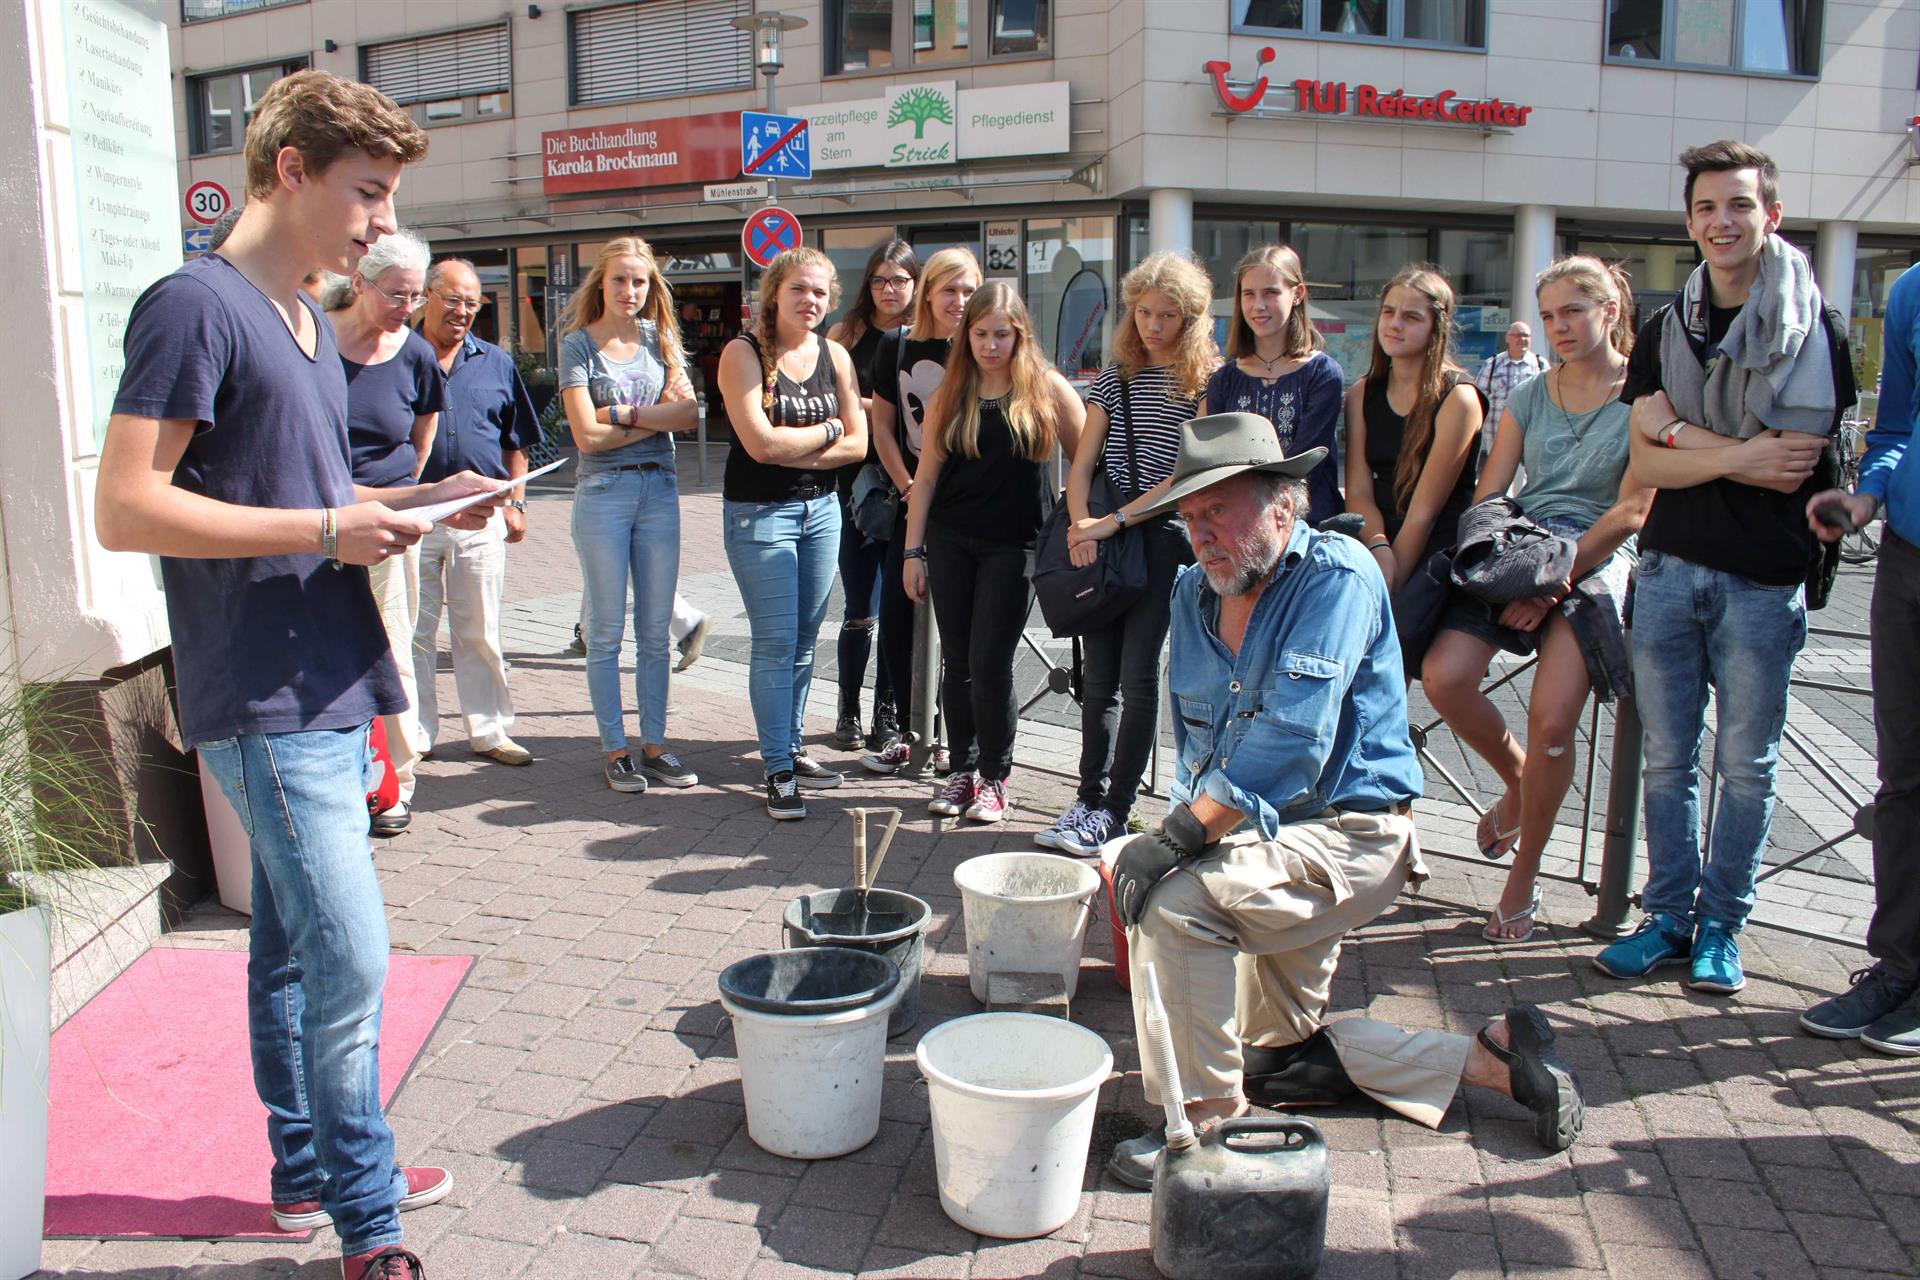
[200,725,407,1253]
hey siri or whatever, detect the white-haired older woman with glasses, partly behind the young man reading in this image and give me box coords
[323,230,447,835]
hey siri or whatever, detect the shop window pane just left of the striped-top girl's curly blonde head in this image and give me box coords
[1029,217,1116,386]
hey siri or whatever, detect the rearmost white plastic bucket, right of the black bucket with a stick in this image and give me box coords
[954,854,1100,1004]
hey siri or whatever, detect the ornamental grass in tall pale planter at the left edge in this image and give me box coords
[0,670,125,1280]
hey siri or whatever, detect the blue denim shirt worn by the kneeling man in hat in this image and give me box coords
[1167,520,1423,841]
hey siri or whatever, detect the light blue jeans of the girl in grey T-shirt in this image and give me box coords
[574,468,680,752]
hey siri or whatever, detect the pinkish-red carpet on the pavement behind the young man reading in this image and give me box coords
[46,946,472,1240]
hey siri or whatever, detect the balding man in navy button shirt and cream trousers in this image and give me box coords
[413,257,540,764]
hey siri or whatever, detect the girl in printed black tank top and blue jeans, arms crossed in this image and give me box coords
[720,248,866,818]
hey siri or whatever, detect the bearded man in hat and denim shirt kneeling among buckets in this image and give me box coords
[1112,413,1584,1186]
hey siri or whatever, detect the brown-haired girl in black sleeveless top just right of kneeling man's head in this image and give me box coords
[1346,265,1486,591]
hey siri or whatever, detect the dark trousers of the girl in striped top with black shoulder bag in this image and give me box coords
[1079,518,1192,821]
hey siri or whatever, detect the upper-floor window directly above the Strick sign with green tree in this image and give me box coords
[824,0,1054,75]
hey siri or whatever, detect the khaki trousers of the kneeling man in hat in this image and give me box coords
[1129,810,1471,1126]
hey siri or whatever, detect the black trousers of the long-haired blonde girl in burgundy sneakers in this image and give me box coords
[927,524,1033,781]
